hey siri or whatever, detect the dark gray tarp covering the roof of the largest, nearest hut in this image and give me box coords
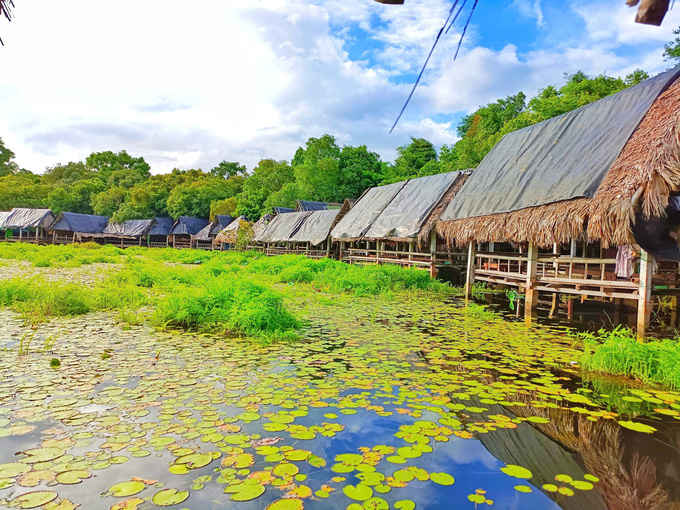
[441,67,680,221]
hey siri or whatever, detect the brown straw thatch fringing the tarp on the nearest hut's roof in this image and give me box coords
[437,68,680,247]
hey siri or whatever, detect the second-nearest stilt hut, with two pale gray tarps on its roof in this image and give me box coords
[332,172,469,271]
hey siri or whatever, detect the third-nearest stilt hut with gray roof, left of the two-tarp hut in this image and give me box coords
[254,209,340,258]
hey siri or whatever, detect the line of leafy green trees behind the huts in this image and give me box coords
[0,66,652,221]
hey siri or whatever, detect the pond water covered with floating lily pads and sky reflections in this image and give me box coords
[0,296,680,510]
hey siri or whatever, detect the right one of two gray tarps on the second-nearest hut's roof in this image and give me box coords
[364,172,460,239]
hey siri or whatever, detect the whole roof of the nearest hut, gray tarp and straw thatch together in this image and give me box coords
[437,68,680,246]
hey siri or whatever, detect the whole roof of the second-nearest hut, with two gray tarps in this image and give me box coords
[332,172,467,242]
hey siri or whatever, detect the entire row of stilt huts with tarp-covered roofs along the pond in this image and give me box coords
[0,67,680,332]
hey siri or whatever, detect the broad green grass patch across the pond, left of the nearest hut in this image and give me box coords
[0,243,455,342]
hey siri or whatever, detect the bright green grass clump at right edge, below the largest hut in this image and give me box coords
[580,326,680,388]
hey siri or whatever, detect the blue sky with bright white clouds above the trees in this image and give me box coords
[0,0,680,173]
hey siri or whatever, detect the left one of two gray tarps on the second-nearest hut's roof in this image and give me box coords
[331,181,408,239]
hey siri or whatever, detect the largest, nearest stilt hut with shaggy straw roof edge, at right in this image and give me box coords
[437,68,680,334]
